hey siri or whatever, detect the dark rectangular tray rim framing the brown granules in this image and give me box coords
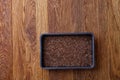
[40,32,95,69]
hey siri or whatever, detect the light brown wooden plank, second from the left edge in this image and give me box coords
[12,0,26,80]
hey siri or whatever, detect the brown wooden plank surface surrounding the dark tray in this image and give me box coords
[0,0,120,80]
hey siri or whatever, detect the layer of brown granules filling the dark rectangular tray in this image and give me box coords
[43,36,92,67]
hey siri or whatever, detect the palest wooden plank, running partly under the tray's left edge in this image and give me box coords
[36,0,49,80]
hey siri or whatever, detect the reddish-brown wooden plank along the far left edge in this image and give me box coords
[0,0,13,80]
